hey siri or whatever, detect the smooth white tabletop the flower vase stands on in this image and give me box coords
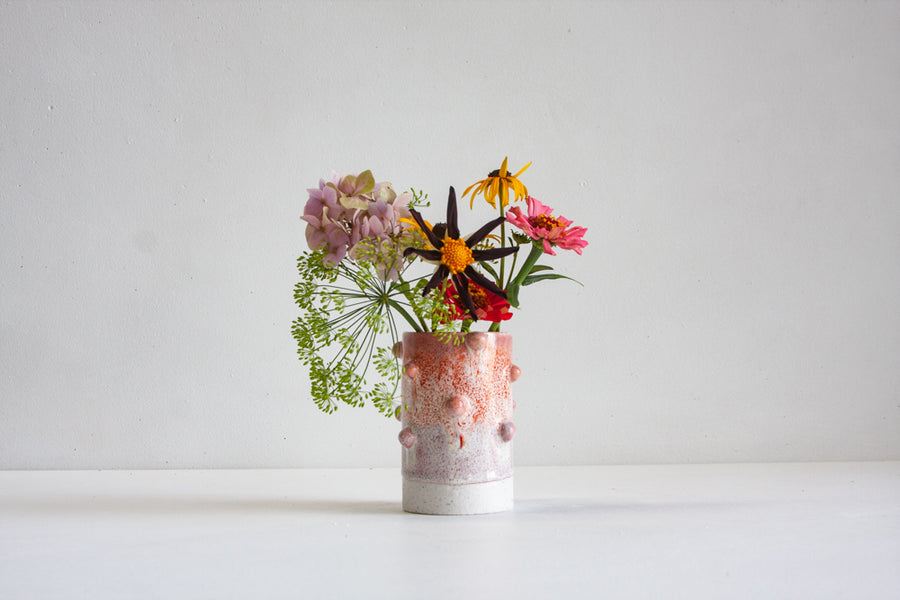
[0,462,900,600]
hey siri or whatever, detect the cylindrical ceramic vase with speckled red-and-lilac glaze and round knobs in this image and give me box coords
[395,332,521,514]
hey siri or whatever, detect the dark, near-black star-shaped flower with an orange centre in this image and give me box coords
[403,186,519,321]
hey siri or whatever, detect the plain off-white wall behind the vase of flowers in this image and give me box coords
[0,1,900,468]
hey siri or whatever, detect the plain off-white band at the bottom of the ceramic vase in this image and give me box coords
[403,477,513,515]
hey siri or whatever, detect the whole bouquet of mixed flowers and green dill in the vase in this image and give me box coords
[292,159,587,415]
